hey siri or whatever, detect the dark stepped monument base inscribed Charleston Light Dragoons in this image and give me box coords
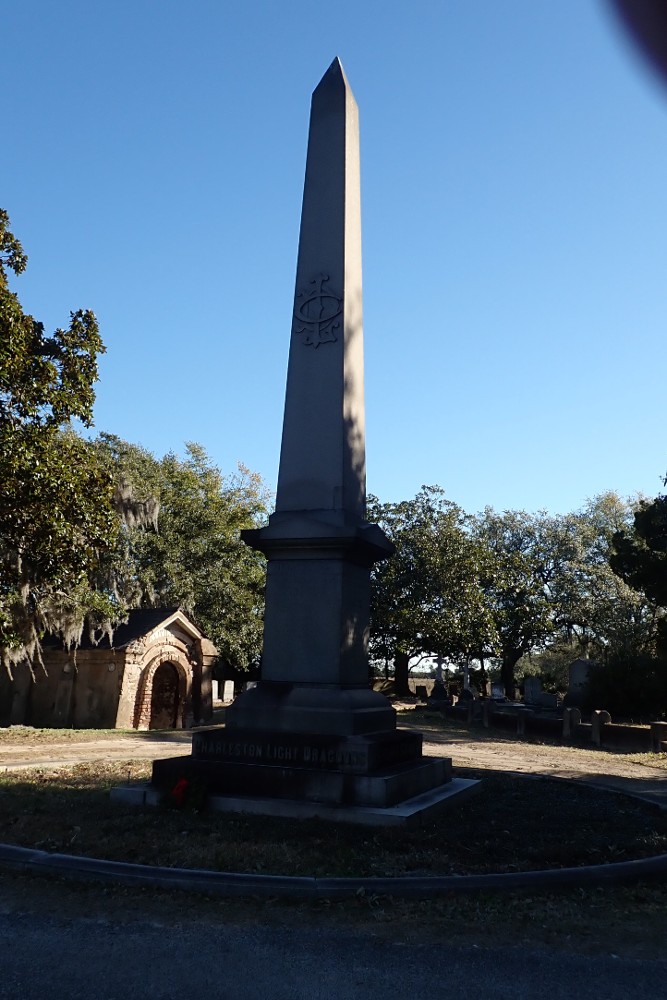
[144,726,468,822]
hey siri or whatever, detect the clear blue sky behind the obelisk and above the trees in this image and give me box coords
[5,0,667,513]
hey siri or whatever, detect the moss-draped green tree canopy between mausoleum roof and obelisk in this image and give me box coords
[94,434,267,668]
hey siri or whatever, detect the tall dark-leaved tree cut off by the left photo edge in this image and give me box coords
[0,210,116,669]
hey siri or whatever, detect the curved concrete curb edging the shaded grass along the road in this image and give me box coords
[0,844,667,900]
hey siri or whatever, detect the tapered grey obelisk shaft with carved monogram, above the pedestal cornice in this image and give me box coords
[276,59,366,520]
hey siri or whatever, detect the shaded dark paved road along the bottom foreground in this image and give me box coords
[0,913,667,1000]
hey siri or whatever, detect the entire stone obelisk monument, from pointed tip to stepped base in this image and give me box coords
[153,59,470,822]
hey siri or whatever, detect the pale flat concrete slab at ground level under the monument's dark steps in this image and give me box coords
[111,778,481,826]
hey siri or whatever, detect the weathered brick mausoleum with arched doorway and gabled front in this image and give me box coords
[0,608,217,729]
